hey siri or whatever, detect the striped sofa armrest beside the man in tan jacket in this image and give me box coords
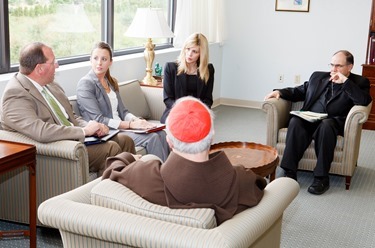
[0,130,89,223]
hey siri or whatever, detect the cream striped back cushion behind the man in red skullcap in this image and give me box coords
[91,179,216,229]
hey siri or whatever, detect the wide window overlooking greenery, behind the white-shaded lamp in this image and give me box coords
[0,0,176,73]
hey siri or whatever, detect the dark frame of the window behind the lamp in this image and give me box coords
[0,0,177,74]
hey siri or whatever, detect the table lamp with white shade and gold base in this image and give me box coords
[125,8,174,85]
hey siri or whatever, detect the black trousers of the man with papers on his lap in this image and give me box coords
[280,116,339,177]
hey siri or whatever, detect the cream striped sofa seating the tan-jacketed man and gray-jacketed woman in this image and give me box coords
[0,80,164,224]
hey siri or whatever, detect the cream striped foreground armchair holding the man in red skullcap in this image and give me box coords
[38,178,299,248]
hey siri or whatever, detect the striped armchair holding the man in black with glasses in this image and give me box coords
[262,98,372,190]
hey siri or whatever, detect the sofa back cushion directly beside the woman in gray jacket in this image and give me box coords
[119,80,151,119]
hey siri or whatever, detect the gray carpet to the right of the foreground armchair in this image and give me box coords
[277,130,375,248]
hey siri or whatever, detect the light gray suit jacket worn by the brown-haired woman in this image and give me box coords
[77,70,129,126]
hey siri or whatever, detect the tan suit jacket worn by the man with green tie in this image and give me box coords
[1,73,87,142]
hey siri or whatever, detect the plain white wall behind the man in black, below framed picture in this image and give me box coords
[220,0,371,105]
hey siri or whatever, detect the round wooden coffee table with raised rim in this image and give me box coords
[210,141,279,181]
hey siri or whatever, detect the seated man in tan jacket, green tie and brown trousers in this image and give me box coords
[1,42,135,175]
